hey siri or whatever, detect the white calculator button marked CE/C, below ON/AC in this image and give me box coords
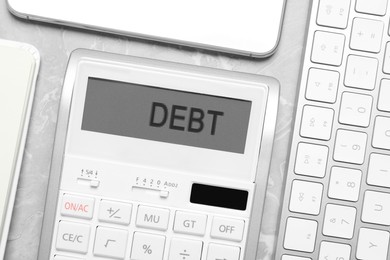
[56,221,91,254]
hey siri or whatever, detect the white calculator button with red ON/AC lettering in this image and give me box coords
[61,194,95,219]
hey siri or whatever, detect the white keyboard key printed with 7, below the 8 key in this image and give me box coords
[322,204,356,238]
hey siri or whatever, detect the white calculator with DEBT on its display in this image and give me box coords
[38,50,279,260]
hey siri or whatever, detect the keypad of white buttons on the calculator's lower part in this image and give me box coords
[54,193,245,260]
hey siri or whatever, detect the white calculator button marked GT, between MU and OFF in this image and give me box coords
[173,211,207,235]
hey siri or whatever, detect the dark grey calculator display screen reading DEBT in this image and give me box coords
[81,78,252,154]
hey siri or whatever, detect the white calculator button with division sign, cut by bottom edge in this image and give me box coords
[169,238,203,260]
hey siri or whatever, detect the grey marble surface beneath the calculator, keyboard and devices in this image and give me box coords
[0,0,310,260]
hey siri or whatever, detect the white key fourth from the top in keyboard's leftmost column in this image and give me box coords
[301,106,334,140]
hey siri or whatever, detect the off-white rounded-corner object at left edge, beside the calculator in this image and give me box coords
[0,40,39,259]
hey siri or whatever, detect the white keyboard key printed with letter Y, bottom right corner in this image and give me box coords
[356,228,389,260]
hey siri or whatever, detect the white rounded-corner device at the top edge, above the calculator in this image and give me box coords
[8,0,285,57]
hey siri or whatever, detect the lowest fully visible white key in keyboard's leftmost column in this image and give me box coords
[284,217,318,252]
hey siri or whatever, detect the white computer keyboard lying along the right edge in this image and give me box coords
[275,0,390,260]
